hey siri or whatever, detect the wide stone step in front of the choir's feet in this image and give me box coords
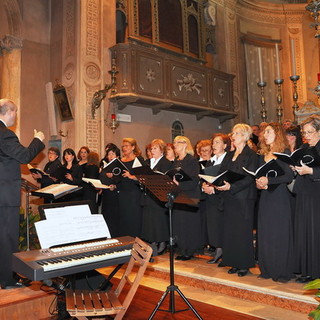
[146,254,318,315]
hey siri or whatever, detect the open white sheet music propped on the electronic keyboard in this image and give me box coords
[35,202,111,249]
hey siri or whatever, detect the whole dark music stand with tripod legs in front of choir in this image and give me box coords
[136,175,202,320]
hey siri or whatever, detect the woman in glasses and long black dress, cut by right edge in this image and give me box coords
[292,115,320,283]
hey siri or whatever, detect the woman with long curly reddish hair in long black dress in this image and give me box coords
[256,123,293,282]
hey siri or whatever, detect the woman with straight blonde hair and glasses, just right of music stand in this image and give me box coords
[172,136,203,261]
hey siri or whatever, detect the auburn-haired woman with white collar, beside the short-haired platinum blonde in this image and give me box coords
[202,133,230,263]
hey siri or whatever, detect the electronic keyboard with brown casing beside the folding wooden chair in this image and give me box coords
[12,236,134,281]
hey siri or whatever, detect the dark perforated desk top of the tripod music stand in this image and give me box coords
[136,175,199,206]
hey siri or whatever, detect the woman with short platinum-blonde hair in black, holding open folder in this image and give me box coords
[216,123,258,277]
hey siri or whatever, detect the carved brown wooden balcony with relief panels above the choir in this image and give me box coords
[111,43,236,120]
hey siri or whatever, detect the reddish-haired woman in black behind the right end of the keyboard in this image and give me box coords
[117,138,144,237]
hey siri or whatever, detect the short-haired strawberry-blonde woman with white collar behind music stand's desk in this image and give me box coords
[142,139,172,254]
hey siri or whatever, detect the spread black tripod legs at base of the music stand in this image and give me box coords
[148,285,202,320]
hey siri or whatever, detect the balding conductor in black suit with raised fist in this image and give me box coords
[0,99,44,289]
